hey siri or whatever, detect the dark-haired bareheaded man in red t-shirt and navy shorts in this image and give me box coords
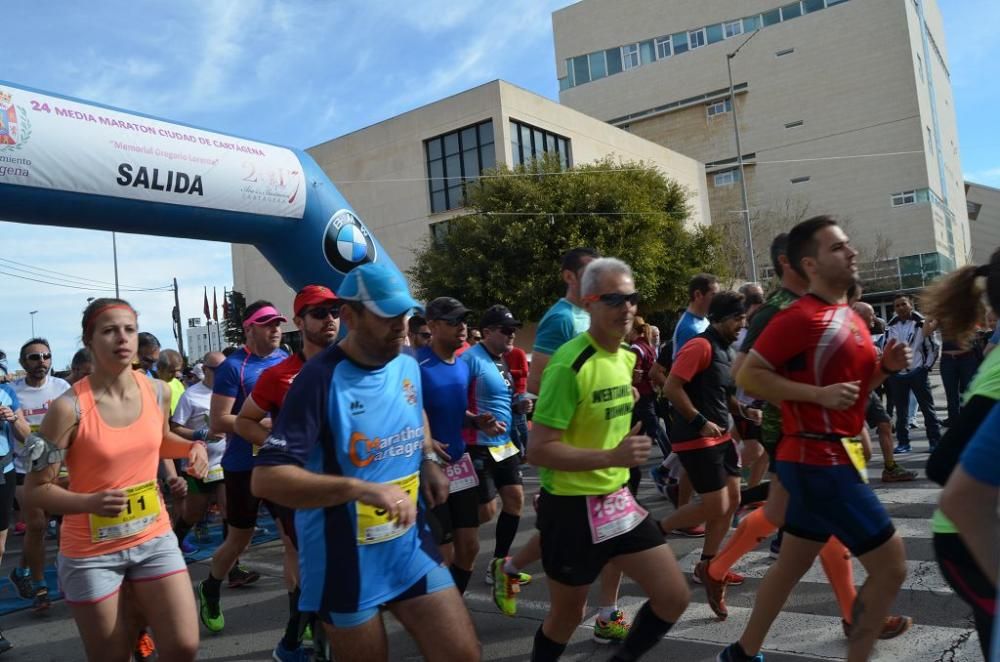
[720,216,910,662]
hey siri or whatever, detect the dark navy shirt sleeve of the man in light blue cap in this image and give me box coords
[256,362,333,467]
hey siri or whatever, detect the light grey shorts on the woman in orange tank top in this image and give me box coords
[56,531,187,604]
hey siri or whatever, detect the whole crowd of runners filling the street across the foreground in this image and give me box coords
[0,216,1000,662]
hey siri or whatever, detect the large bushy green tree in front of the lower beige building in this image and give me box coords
[408,155,724,320]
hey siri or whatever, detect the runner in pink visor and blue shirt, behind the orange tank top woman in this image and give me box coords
[198,301,288,632]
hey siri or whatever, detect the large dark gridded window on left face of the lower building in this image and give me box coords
[424,120,496,214]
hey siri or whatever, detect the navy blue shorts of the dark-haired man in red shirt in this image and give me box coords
[778,460,896,556]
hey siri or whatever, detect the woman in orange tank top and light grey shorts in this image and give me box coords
[25,299,208,662]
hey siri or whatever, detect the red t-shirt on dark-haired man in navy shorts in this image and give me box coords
[751,294,878,466]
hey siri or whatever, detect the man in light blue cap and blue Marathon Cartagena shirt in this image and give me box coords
[253,263,480,662]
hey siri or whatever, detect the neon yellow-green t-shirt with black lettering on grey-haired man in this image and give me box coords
[534,332,635,496]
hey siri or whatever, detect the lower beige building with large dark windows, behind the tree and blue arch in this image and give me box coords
[233,81,711,320]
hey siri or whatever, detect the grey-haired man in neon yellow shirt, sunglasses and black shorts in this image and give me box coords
[528,258,689,662]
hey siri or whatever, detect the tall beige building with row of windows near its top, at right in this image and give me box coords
[552,0,971,291]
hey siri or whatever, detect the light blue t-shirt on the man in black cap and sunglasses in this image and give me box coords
[460,343,514,446]
